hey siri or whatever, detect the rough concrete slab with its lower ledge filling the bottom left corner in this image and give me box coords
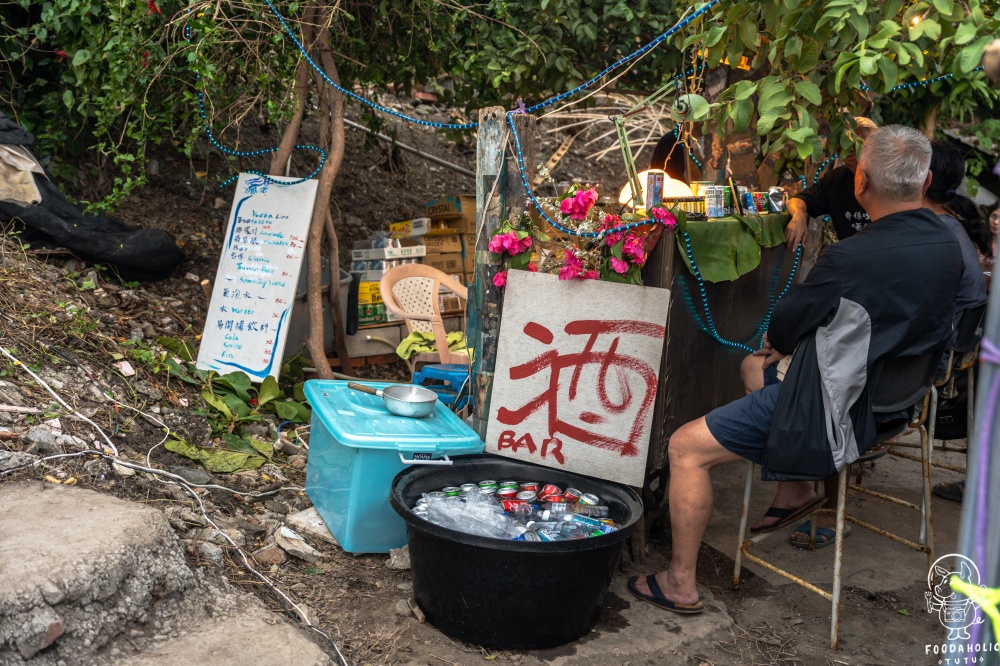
[0,481,332,666]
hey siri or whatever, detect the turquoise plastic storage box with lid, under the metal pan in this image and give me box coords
[305,380,483,553]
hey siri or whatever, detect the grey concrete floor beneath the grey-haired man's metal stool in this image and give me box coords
[705,435,965,592]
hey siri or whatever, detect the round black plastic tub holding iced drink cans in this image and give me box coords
[389,456,642,650]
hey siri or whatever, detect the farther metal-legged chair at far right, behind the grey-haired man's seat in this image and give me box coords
[889,303,986,474]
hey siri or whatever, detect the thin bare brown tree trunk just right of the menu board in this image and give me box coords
[303,6,354,379]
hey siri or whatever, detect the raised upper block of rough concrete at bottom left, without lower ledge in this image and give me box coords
[0,481,193,664]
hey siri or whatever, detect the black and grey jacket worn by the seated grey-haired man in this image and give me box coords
[761,208,962,481]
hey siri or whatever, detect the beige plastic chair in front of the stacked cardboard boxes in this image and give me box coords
[379,264,469,368]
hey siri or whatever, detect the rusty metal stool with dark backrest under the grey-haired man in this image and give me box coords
[733,347,944,650]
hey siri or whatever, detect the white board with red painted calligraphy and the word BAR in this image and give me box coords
[486,271,670,482]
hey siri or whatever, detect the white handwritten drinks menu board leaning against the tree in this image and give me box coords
[198,173,316,382]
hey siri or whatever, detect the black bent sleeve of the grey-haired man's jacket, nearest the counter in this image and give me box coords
[767,247,840,354]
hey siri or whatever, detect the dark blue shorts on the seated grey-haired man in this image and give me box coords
[705,364,781,465]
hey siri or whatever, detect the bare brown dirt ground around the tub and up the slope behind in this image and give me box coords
[0,98,941,666]
